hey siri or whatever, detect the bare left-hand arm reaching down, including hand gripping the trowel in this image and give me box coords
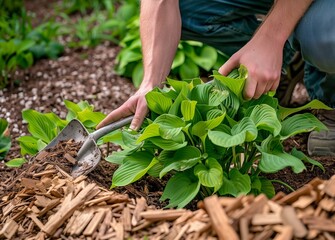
[97,0,181,130]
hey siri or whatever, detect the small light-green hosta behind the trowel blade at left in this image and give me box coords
[18,100,105,155]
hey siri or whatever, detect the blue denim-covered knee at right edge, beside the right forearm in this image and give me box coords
[292,0,335,108]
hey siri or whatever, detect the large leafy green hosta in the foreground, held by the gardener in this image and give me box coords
[107,66,329,208]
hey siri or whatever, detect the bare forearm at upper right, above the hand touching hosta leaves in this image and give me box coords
[255,0,313,46]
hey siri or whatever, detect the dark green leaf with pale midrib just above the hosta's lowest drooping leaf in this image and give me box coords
[159,146,201,178]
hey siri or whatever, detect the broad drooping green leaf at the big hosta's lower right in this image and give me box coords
[259,152,306,173]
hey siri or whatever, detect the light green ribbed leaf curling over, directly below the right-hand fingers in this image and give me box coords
[250,104,281,136]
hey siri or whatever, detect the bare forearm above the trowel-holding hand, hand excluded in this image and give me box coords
[140,0,181,88]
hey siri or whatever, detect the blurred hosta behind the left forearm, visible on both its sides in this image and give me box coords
[116,17,227,87]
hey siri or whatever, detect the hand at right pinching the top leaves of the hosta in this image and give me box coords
[219,35,283,100]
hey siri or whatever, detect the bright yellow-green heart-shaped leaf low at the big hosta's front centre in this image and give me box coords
[194,158,223,192]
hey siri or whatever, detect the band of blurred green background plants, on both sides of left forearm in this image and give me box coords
[0,0,227,89]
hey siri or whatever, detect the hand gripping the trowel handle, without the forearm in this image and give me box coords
[96,87,152,131]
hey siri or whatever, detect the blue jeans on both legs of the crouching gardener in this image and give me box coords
[179,0,335,107]
